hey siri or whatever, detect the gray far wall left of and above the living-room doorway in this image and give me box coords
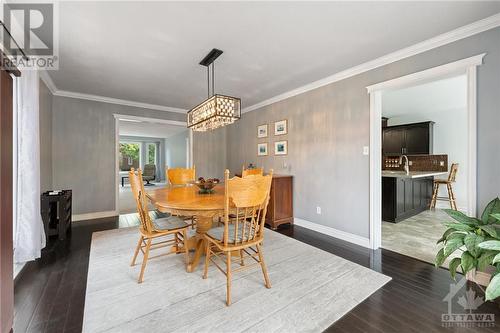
[52,96,186,214]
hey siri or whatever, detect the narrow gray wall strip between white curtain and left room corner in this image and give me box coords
[39,80,52,192]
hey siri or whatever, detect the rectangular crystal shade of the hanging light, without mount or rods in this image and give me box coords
[188,94,241,132]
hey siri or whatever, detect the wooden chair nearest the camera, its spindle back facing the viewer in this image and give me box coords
[203,170,273,306]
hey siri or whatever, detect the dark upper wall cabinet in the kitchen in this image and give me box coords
[382,121,434,156]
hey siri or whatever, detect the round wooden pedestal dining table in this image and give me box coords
[146,184,224,272]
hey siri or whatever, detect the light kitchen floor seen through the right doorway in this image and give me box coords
[382,209,460,268]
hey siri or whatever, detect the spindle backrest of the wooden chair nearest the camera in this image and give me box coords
[223,169,273,246]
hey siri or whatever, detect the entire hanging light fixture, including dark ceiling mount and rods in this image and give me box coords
[187,49,241,132]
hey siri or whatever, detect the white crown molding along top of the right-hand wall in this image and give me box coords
[242,14,500,113]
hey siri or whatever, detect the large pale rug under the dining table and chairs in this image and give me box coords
[83,228,391,333]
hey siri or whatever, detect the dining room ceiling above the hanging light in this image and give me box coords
[50,1,500,109]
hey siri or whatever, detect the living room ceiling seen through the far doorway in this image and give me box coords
[119,120,187,138]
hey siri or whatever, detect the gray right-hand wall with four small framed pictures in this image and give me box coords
[227,28,500,237]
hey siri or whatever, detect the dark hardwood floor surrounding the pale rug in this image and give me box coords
[14,218,500,333]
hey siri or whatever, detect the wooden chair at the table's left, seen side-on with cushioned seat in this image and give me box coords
[129,169,189,283]
